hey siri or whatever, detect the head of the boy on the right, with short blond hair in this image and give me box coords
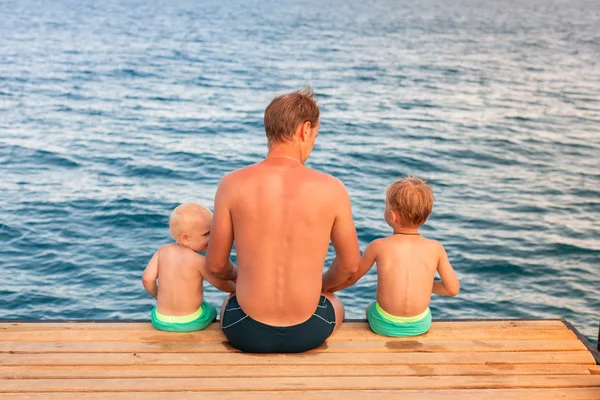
[386,176,433,226]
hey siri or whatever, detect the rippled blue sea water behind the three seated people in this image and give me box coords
[0,0,600,340]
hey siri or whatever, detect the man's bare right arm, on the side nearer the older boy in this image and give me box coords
[323,181,360,291]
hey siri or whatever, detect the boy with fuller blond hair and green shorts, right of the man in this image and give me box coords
[336,177,460,336]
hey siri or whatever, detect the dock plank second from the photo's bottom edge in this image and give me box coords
[0,375,600,394]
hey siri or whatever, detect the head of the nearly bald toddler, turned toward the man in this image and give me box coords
[169,203,212,251]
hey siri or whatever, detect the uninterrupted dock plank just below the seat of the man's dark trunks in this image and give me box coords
[0,351,595,366]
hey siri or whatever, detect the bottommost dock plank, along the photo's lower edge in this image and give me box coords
[7,388,598,400]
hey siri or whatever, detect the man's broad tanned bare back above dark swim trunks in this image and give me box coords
[219,157,356,326]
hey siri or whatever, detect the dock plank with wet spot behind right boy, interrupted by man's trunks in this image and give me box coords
[0,340,587,354]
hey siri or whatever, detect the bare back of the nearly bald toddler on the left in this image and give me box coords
[156,243,205,316]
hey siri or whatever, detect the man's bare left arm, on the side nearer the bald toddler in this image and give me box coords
[206,176,237,281]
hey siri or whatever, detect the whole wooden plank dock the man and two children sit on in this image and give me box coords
[0,320,600,400]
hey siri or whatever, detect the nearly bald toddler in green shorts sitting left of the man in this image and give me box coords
[142,203,235,332]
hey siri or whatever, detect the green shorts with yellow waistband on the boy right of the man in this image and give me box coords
[367,302,431,337]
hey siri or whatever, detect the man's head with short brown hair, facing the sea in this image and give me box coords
[265,86,320,157]
